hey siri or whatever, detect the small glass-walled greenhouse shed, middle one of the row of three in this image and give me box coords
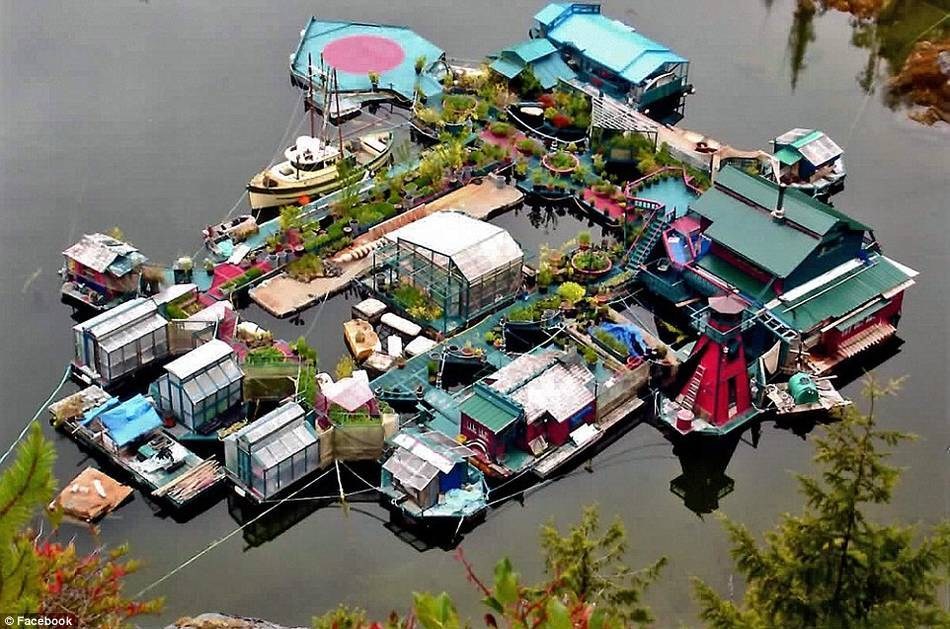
[155,339,244,432]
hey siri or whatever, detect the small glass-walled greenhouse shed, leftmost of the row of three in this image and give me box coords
[73,297,168,386]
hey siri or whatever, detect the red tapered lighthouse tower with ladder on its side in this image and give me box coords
[675,295,756,433]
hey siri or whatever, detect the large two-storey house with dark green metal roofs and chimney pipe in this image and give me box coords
[644,166,917,373]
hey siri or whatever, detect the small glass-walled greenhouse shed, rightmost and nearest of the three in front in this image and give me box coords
[224,402,320,501]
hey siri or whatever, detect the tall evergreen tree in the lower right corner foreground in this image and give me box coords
[694,380,950,629]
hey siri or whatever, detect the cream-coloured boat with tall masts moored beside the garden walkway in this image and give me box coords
[247,66,393,210]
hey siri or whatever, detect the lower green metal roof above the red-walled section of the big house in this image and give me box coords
[772,256,912,332]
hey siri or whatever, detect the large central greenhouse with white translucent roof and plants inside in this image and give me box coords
[373,211,524,332]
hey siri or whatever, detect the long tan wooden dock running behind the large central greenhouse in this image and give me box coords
[249,178,524,319]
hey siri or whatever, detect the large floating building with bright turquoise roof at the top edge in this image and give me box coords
[531,2,692,120]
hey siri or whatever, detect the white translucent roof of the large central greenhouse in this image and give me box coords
[386,211,524,281]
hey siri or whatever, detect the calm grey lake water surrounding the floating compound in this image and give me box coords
[0,0,950,626]
